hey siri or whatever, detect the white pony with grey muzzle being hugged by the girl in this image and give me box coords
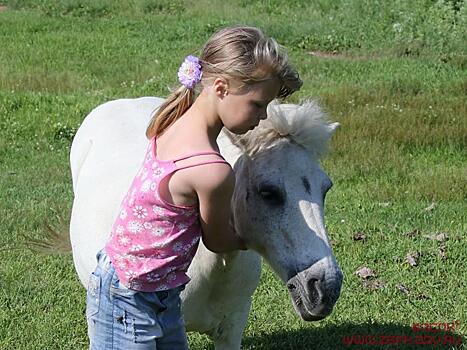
[70,97,342,350]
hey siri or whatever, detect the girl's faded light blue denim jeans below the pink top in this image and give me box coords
[86,250,188,350]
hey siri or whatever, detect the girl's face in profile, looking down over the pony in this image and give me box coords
[218,78,280,134]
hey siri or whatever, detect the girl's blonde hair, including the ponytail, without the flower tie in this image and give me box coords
[146,26,302,138]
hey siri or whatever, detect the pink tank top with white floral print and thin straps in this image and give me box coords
[105,138,228,292]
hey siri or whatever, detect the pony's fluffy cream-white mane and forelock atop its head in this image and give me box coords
[227,100,339,158]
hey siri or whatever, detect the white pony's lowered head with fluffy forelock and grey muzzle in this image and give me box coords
[228,101,342,320]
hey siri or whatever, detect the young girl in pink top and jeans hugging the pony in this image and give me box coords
[86,27,301,350]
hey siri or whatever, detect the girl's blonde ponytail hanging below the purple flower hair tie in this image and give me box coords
[146,85,195,139]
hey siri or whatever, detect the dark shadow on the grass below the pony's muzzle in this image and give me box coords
[242,324,467,350]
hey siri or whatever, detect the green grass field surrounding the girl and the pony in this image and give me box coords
[0,0,467,350]
